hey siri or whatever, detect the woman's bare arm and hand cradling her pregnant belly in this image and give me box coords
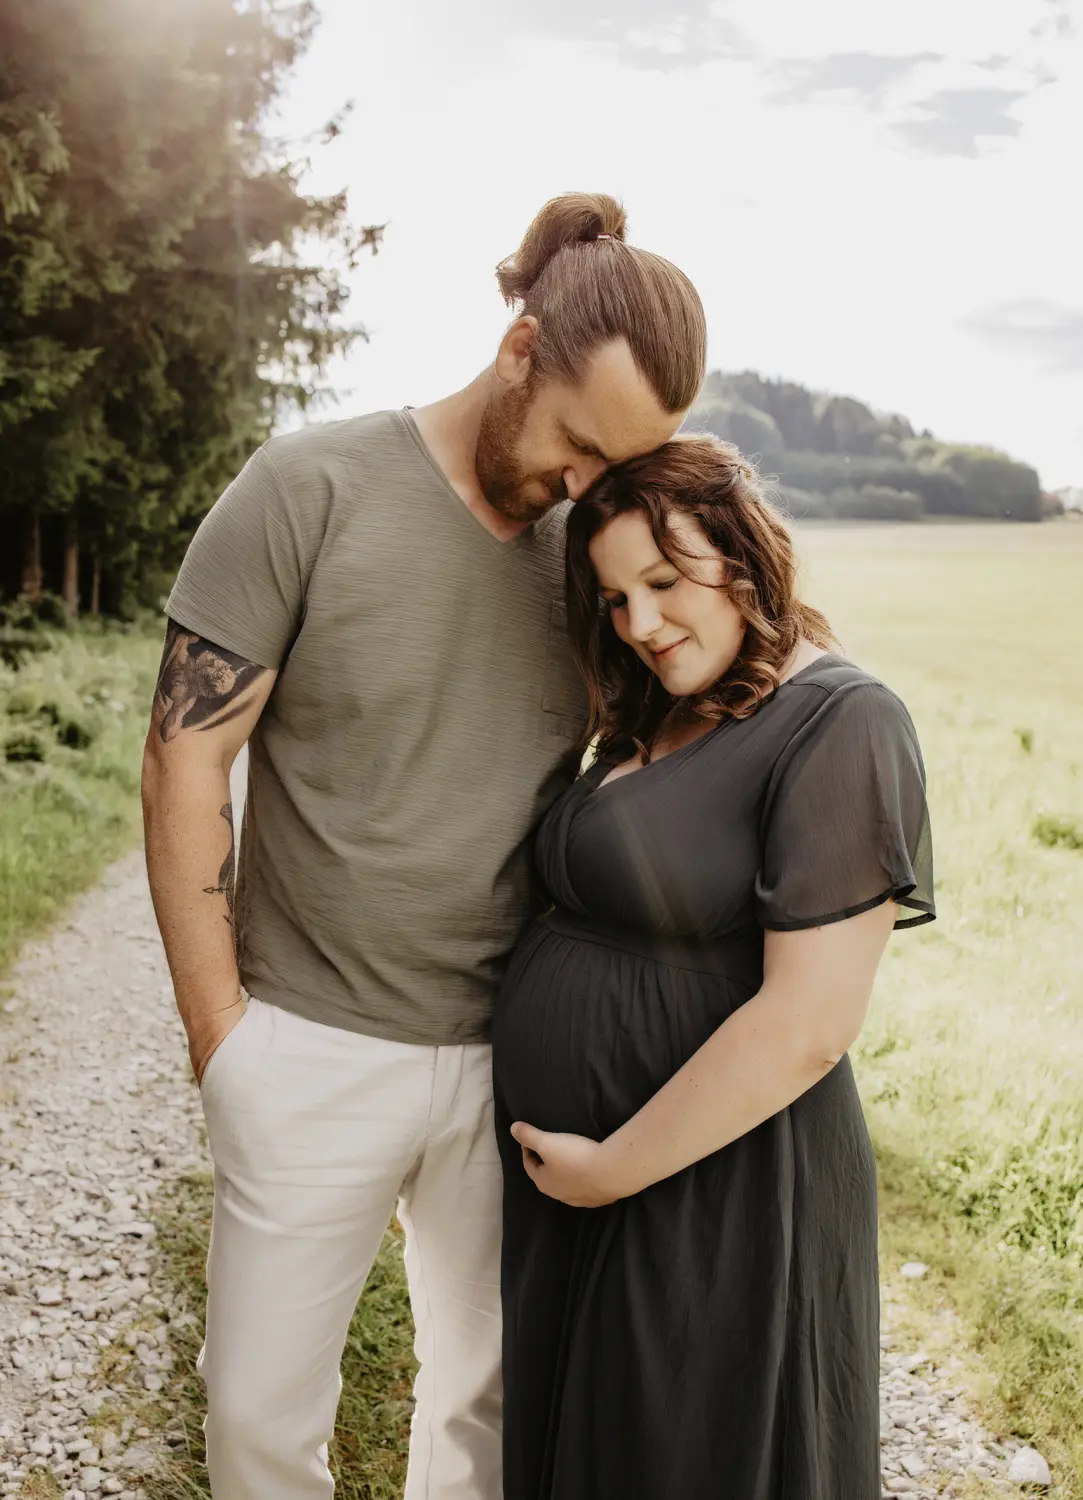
[513,902,899,1208]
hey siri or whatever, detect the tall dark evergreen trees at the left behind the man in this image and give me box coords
[0,0,367,615]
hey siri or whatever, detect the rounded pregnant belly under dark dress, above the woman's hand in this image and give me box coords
[492,923,758,1139]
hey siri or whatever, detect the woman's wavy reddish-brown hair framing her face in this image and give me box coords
[566,437,836,759]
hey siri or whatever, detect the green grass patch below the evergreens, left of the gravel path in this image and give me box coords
[0,629,161,974]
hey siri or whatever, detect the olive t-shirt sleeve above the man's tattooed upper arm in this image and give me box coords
[165,449,305,669]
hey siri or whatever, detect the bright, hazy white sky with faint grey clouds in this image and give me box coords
[282,0,1083,488]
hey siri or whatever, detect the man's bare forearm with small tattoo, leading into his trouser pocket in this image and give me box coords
[143,737,240,1053]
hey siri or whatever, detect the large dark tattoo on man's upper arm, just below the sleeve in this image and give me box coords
[155,620,267,744]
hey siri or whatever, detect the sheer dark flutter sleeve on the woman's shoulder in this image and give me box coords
[756,683,936,932]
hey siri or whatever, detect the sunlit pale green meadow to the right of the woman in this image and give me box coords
[800,522,1083,1497]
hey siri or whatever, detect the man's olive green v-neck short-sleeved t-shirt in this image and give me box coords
[167,411,585,1044]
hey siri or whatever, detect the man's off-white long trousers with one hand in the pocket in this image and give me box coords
[200,999,501,1500]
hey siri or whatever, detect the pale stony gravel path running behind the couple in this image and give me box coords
[0,855,1037,1500]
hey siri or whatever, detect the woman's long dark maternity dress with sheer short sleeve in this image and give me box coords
[494,657,933,1500]
